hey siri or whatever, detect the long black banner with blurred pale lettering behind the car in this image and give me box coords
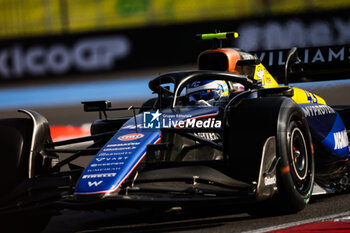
[0,9,350,82]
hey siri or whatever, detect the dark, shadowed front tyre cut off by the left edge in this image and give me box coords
[0,118,51,232]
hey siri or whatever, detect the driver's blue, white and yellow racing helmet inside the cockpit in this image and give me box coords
[186,80,228,101]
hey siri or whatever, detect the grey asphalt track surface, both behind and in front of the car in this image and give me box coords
[0,74,350,233]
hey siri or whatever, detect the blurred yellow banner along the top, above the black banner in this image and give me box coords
[0,0,350,38]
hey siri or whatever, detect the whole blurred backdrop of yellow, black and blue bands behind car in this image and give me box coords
[0,0,350,125]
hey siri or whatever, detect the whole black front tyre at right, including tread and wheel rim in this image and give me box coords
[224,96,314,216]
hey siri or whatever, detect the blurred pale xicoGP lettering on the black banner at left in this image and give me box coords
[0,36,130,78]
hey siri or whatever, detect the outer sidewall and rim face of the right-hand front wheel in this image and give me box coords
[277,102,315,213]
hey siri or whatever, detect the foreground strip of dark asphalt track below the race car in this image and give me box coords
[44,194,350,233]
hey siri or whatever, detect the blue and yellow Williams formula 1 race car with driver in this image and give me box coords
[0,32,350,232]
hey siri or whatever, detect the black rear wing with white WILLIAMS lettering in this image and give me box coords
[251,45,350,83]
